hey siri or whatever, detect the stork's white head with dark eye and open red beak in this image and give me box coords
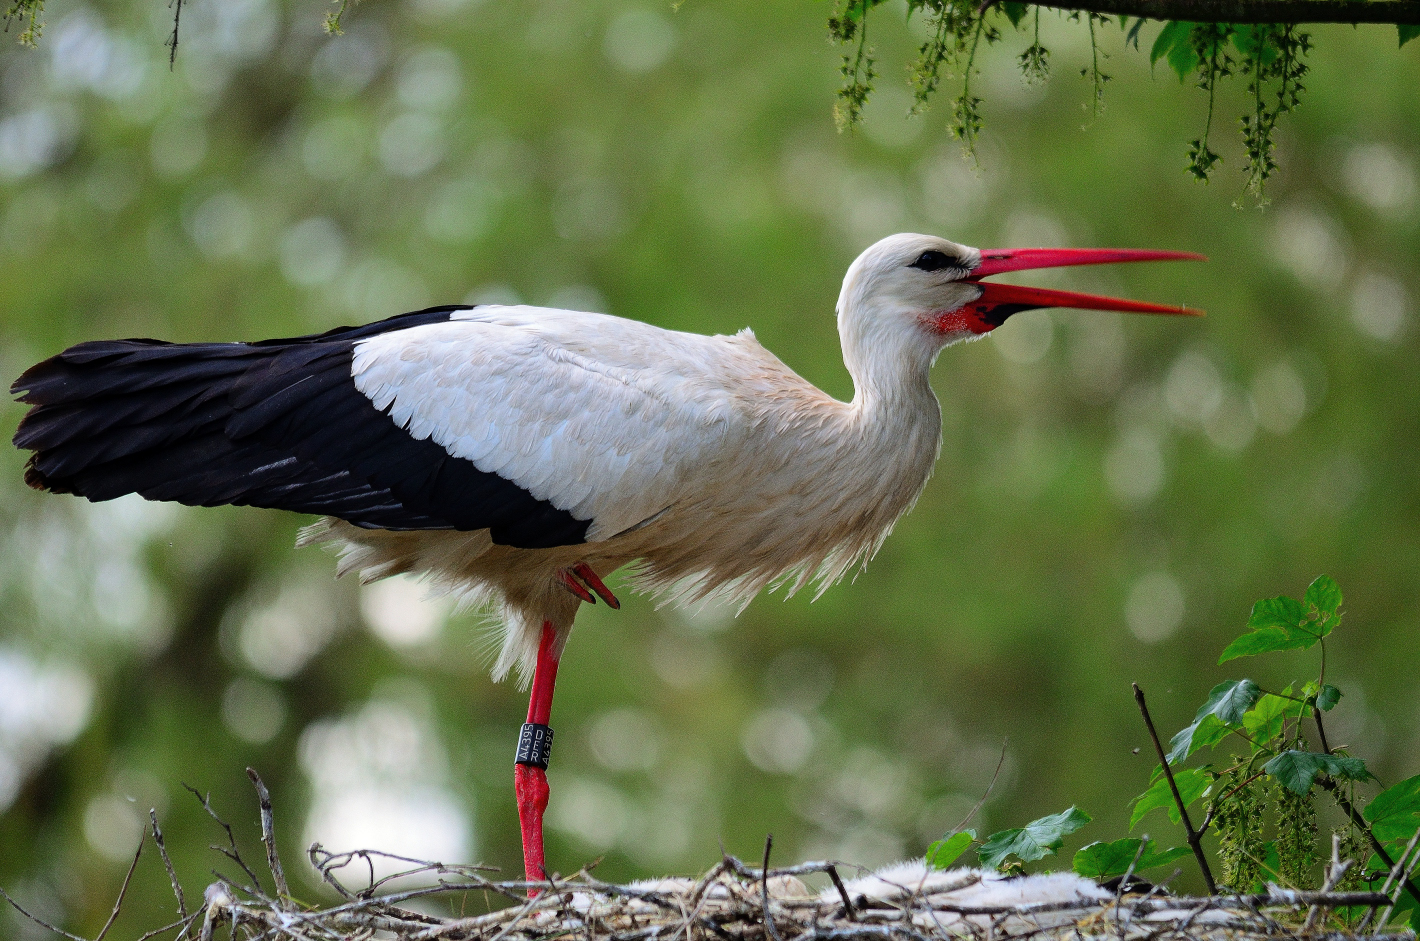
[838,233,1204,383]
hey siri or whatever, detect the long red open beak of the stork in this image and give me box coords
[964,248,1207,332]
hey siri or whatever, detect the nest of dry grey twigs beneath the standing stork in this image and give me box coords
[0,772,1416,941]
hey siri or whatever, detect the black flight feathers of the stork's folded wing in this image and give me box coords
[11,307,591,548]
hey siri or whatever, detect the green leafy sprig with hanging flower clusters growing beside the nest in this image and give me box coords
[927,573,1420,927]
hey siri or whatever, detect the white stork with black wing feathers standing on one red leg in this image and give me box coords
[11,234,1201,879]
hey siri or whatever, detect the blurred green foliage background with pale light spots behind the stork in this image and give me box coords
[0,0,1420,937]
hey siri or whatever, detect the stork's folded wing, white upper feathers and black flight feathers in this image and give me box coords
[13,308,738,548]
